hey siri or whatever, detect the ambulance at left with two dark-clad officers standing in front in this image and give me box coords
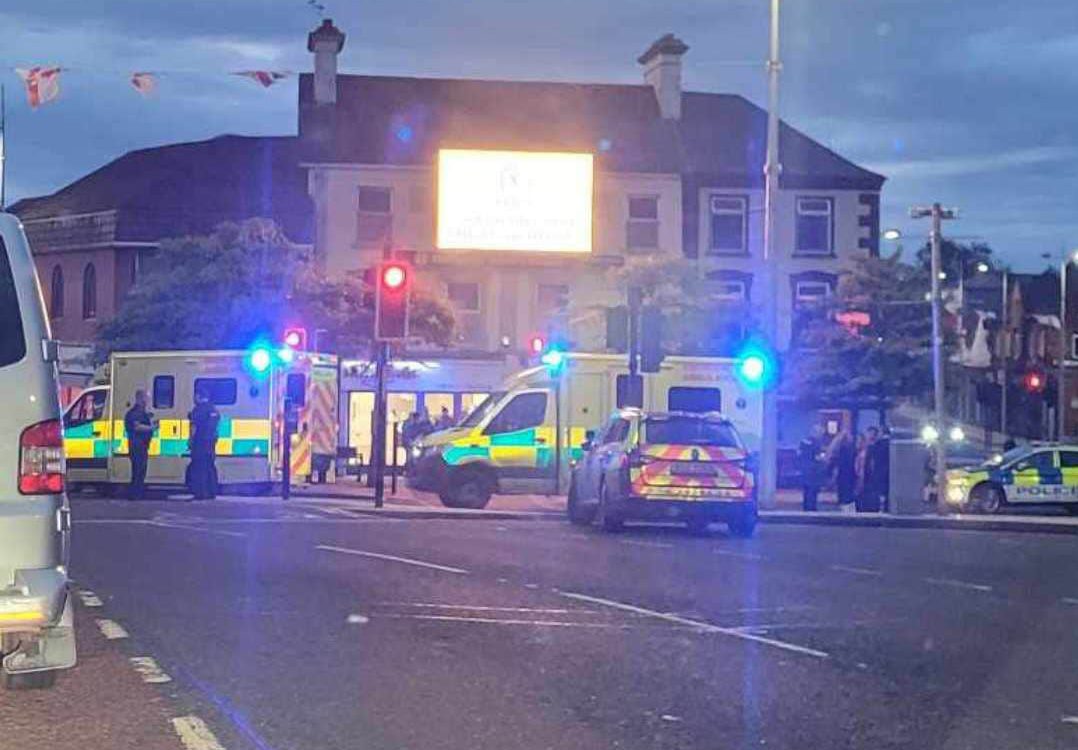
[64,348,337,496]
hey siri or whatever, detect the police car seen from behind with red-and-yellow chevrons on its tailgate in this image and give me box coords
[568,408,757,537]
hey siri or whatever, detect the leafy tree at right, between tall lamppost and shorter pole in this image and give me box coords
[786,252,932,408]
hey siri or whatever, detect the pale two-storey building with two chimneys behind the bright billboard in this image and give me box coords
[299,20,884,351]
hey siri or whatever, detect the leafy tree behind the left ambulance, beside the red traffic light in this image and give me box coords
[97,219,454,359]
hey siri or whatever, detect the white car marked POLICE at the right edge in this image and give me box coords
[946,444,1078,514]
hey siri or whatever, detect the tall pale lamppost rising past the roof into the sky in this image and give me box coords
[758,0,785,503]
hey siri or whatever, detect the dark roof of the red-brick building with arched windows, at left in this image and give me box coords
[11,136,314,242]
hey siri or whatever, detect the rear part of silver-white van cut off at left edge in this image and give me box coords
[0,213,75,688]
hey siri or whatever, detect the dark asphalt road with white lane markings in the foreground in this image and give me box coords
[6,500,1078,750]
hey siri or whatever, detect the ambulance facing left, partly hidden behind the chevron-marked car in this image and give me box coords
[409,352,763,509]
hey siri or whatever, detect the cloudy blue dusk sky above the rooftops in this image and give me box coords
[0,0,1078,269]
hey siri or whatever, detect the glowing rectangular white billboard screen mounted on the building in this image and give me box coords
[438,149,593,252]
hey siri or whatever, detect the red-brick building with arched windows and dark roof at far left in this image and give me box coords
[11,136,313,344]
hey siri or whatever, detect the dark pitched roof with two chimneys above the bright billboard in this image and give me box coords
[300,74,884,190]
